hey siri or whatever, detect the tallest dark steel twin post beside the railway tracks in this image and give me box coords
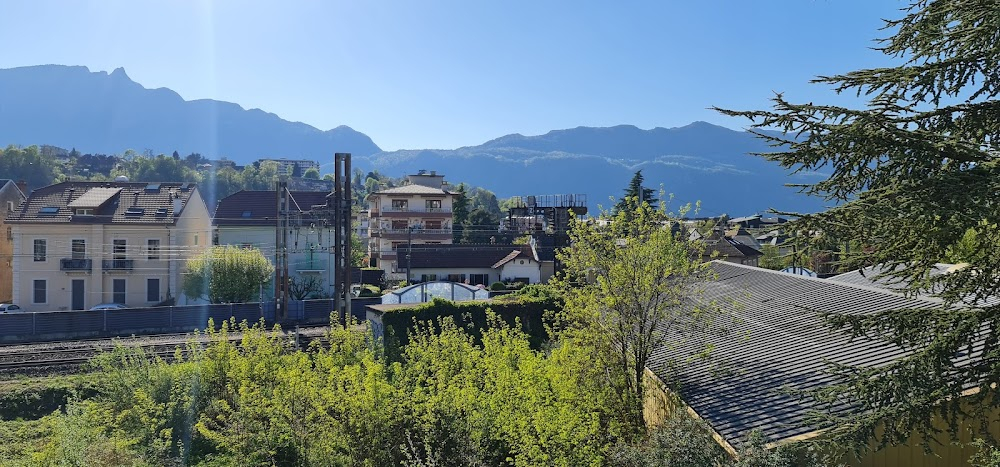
[327,152,352,326]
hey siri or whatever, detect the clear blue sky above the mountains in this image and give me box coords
[0,0,906,150]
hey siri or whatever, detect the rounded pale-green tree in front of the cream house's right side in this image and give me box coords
[182,245,274,303]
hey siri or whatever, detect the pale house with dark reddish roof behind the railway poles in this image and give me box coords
[212,190,334,299]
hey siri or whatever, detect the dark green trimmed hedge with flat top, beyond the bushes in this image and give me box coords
[382,295,561,361]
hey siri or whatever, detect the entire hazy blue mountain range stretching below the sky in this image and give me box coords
[0,65,823,215]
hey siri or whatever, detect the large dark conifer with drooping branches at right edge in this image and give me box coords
[721,0,1000,454]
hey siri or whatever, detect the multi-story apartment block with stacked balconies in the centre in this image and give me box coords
[368,170,456,280]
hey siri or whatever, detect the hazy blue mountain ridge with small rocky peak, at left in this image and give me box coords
[0,65,380,163]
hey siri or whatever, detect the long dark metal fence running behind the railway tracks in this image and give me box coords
[0,298,380,343]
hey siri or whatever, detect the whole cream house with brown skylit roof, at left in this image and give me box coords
[7,182,212,311]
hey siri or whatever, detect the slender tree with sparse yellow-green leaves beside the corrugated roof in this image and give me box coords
[558,198,718,427]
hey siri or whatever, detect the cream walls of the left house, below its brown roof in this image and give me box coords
[12,185,212,311]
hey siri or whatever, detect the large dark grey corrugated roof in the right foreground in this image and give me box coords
[648,261,939,446]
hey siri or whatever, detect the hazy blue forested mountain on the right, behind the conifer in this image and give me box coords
[368,122,824,215]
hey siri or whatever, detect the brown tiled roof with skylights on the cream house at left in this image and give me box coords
[8,182,197,225]
